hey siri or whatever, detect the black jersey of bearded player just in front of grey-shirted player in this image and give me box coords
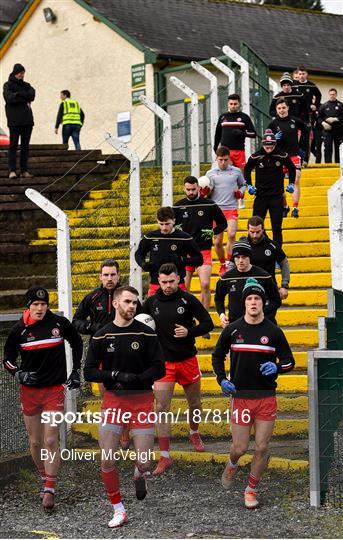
[173,197,227,251]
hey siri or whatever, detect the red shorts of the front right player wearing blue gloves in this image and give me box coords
[231,396,277,426]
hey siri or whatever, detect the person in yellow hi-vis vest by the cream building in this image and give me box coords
[55,90,85,150]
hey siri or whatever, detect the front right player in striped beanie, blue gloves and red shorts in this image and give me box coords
[212,278,295,509]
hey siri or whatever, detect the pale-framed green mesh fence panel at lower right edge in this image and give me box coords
[308,350,343,508]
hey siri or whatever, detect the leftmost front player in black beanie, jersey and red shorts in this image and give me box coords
[3,287,83,510]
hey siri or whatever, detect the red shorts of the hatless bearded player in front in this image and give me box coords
[101,390,155,429]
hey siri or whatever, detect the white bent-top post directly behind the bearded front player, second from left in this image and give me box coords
[105,133,142,298]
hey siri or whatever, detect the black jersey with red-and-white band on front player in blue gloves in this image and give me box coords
[212,317,295,399]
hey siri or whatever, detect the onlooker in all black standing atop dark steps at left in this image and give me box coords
[3,64,36,179]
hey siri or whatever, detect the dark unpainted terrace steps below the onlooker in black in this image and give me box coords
[0,144,126,311]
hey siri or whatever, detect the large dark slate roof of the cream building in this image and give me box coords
[87,0,343,76]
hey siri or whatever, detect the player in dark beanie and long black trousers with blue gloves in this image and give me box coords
[244,129,296,247]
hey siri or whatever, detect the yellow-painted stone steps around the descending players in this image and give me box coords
[31,166,339,468]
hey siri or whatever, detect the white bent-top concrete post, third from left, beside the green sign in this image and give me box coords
[139,96,173,206]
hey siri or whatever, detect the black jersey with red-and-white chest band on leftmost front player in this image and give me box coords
[3,310,83,388]
